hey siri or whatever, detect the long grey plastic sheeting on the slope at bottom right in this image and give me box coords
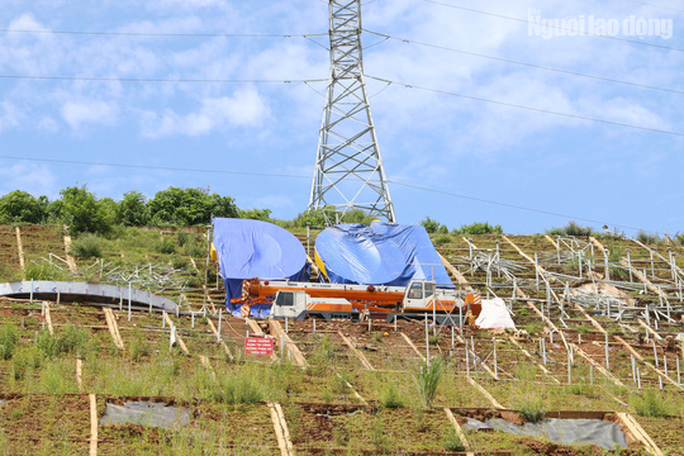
[463,418,627,450]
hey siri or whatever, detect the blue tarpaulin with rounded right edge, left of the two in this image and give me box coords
[212,218,308,316]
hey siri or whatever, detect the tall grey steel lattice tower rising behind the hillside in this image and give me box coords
[309,0,396,223]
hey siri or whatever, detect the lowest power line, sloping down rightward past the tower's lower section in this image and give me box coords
[0,155,641,231]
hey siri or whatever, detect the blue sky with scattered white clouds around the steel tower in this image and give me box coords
[0,0,684,235]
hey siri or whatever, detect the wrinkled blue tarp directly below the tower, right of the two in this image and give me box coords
[316,222,453,288]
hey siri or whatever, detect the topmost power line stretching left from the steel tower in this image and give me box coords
[0,29,328,38]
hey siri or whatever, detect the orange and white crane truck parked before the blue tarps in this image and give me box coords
[232,279,482,324]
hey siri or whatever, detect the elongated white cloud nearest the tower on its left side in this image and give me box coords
[143,88,270,138]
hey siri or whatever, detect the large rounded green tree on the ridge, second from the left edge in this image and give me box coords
[48,185,113,234]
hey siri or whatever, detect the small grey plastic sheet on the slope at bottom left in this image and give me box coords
[100,401,190,429]
